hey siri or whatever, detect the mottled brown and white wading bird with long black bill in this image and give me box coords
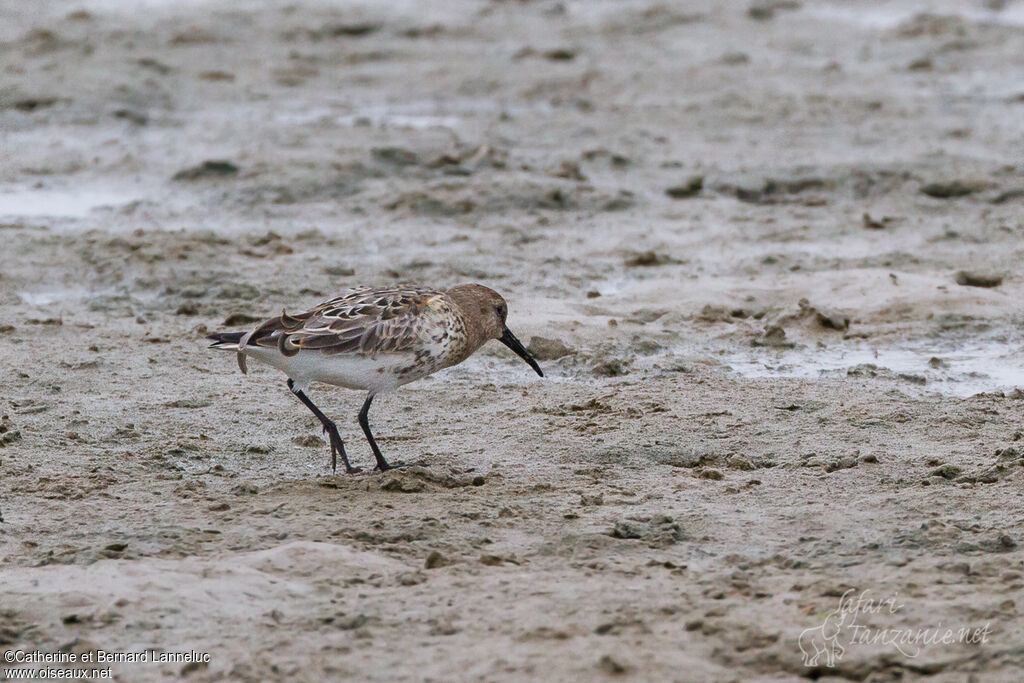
[207,284,544,474]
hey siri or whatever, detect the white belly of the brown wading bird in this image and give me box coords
[245,346,411,393]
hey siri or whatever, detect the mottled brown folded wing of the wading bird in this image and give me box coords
[249,287,446,356]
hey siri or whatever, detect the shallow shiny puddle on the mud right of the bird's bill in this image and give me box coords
[721,343,1024,396]
